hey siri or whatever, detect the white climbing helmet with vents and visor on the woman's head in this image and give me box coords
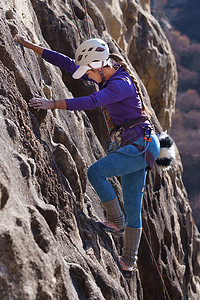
[72,39,109,79]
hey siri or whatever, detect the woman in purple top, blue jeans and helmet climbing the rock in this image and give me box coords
[15,35,160,278]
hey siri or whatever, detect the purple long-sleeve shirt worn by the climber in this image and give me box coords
[42,49,152,141]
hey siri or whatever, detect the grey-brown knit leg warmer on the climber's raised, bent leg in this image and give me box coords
[101,197,126,231]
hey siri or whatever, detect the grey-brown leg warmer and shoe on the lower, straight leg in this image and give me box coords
[120,227,142,278]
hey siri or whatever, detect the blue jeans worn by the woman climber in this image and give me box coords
[88,134,160,228]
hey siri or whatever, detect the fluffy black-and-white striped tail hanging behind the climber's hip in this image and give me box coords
[156,131,176,170]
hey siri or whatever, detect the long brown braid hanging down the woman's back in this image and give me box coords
[109,53,150,116]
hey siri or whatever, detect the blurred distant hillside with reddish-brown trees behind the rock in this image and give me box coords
[152,0,200,229]
